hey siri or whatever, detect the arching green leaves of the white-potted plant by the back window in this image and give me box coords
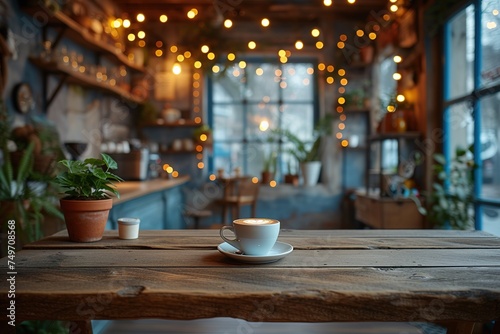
[273,114,333,162]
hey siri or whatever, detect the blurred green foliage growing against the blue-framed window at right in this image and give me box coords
[429,147,476,229]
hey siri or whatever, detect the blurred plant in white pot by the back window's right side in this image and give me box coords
[275,114,333,186]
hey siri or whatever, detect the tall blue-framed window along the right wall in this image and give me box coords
[444,0,500,234]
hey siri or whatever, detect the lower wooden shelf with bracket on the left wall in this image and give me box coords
[29,57,144,105]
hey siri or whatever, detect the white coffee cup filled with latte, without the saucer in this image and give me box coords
[220,218,280,256]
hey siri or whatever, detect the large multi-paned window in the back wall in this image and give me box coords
[208,60,318,180]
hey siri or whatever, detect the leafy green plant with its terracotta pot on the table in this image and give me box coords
[55,153,123,242]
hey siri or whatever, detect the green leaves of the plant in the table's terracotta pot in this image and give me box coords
[55,153,123,199]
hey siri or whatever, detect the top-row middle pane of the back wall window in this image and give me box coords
[245,64,280,103]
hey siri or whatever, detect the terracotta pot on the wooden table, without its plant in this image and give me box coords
[60,198,113,242]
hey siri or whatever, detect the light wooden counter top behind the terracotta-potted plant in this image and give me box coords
[113,176,189,204]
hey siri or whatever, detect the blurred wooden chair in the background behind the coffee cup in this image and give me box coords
[218,177,260,224]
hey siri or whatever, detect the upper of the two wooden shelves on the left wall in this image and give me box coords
[25,6,146,72]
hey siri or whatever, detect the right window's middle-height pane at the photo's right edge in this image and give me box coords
[481,93,500,198]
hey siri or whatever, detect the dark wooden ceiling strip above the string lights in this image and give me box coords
[116,0,389,23]
